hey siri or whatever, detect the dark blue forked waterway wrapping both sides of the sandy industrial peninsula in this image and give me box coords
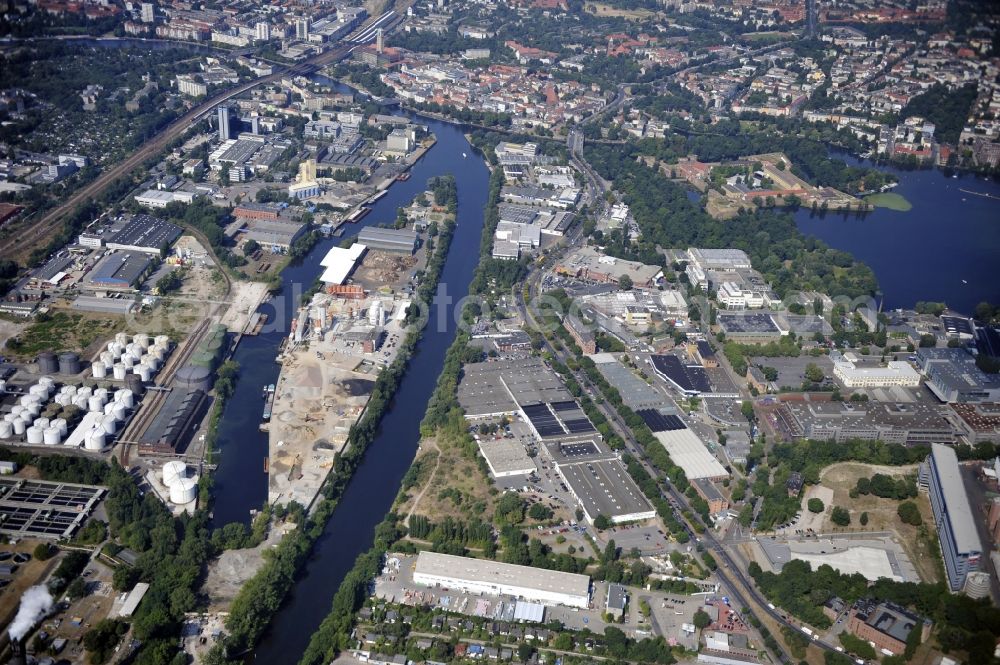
[213,81,489,663]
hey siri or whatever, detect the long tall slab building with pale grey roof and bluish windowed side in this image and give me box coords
[921,443,983,591]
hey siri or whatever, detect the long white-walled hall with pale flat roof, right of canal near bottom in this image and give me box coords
[413,551,590,608]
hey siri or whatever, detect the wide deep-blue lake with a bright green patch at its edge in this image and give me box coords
[795,154,1000,314]
